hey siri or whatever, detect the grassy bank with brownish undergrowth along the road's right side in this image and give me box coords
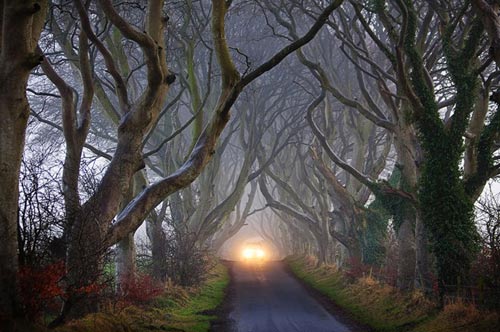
[286,256,500,332]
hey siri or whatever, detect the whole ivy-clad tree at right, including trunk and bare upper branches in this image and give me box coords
[352,1,498,291]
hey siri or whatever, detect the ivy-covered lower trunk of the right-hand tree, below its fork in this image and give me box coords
[419,143,478,291]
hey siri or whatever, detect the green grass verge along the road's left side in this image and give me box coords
[56,263,229,332]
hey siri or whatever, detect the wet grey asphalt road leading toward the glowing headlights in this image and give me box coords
[228,262,359,332]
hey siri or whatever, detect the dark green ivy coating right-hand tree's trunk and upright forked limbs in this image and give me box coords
[403,0,482,290]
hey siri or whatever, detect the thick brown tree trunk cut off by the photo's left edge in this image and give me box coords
[0,0,47,331]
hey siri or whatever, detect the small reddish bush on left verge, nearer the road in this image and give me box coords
[120,273,163,304]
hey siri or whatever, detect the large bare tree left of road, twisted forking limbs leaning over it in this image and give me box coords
[28,0,342,323]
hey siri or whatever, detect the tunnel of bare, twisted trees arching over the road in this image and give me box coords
[0,0,500,331]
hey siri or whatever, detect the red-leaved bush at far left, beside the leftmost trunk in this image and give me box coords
[19,261,66,319]
